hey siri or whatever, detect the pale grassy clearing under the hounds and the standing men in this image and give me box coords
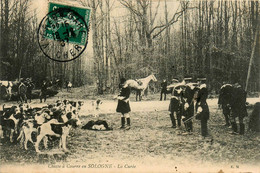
[0,87,260,172]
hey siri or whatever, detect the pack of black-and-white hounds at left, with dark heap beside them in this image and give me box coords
[0,100,112,152]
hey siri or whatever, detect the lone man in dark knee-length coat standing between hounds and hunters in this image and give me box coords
[116,78,131,130]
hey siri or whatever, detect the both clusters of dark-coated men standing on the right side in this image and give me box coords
[166,77,247,137]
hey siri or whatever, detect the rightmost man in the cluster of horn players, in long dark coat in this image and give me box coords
[194,78,209,137]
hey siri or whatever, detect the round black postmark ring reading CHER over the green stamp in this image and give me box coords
[37,8,89,62]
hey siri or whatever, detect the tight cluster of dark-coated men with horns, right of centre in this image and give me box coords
[168,77,209,137]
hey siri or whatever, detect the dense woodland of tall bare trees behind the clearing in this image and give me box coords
[0,0,260,94]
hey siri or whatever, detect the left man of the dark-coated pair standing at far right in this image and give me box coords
[218,84,233,127]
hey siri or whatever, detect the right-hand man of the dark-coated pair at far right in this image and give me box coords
[230,83,247,135]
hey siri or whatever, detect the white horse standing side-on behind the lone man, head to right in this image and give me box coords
[125,74,157,101]
